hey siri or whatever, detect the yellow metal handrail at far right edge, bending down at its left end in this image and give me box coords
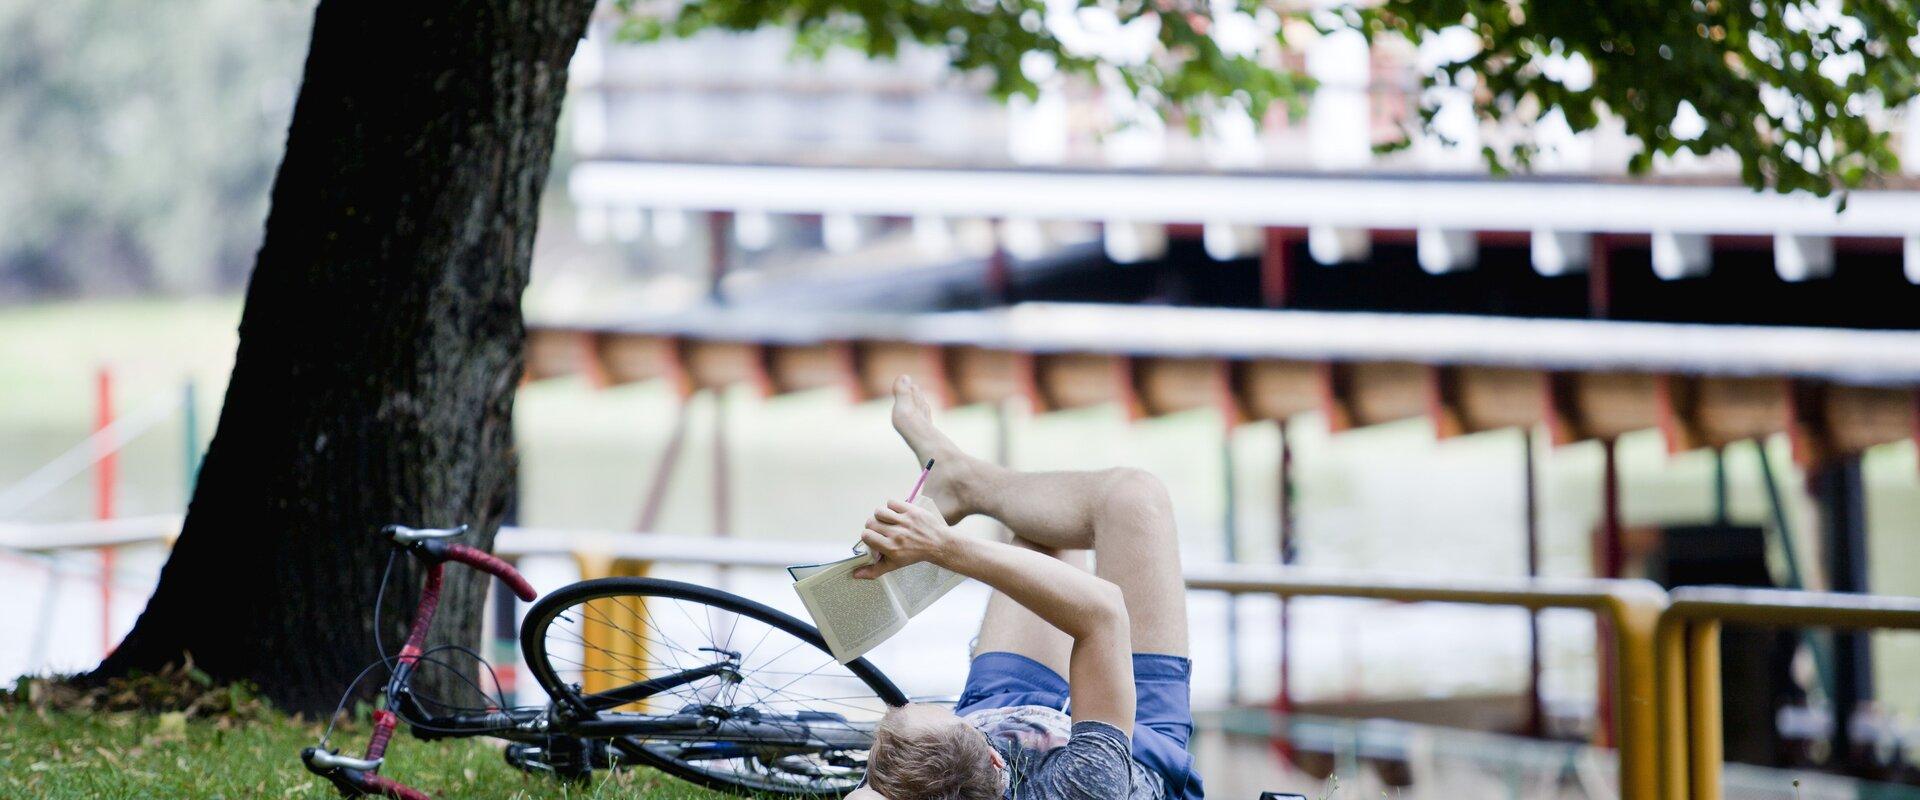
[1653,587,1920,800]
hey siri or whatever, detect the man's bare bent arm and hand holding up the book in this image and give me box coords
[854,501,1137,735]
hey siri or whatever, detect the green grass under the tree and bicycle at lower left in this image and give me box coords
[0,706,722,800]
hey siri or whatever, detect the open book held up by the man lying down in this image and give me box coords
[787,498,966,664]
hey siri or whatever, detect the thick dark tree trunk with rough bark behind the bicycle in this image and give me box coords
[90,0,593,714]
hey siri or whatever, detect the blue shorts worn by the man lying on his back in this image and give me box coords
[954,652,1206,800]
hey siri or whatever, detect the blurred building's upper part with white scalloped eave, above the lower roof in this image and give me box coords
[549,15,1920,328]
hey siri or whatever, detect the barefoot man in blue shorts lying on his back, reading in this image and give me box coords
[852,376,1202,800]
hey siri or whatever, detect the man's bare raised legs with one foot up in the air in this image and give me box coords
[893,378,1188,656]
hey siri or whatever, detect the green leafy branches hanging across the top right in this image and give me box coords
[622,0,1920,194]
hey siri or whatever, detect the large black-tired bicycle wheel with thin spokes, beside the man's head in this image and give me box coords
[520,577,906,796]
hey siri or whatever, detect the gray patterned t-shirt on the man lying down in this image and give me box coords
[966,706,1167,800]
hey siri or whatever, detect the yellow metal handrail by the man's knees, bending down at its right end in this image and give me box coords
[1187,564,1667,800]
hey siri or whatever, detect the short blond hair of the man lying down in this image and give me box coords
[866,708,1002,800]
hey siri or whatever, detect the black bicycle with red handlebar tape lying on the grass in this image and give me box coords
[300,526,906,800]
